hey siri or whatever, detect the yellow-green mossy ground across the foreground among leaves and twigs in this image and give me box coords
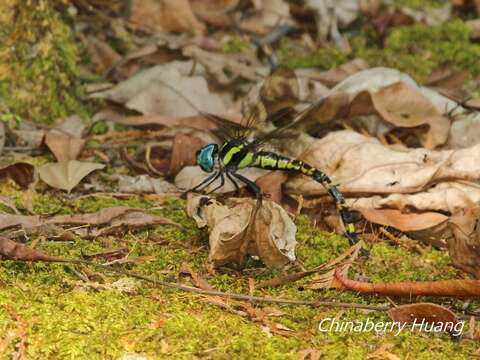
[0,186,478,359]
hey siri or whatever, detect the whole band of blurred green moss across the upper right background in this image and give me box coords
[279,19,480,83]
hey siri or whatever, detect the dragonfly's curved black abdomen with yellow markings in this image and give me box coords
[250,151,359,245]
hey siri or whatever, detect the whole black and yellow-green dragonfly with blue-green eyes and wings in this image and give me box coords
[190,68,359,249]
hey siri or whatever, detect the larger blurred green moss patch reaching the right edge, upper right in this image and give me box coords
[352,20,480,82]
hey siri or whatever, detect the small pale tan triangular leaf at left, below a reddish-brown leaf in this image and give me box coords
[38,160,105,192]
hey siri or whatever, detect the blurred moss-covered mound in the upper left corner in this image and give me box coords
[0,0,86,122]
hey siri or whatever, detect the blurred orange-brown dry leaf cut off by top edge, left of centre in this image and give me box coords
[129,0,205,33]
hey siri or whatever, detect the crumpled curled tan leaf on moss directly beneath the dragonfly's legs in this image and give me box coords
[187,196,296,268]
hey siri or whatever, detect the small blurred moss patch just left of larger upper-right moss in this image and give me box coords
[278,39,349,69]
